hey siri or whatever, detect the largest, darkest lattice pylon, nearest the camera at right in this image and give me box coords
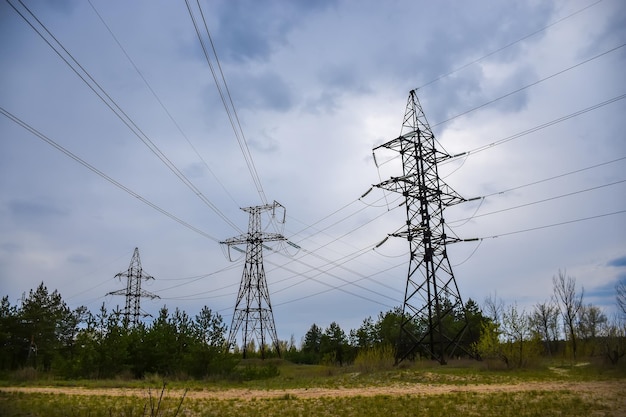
[374,90,467,364]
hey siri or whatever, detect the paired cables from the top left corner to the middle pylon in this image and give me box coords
[7,0,241,232]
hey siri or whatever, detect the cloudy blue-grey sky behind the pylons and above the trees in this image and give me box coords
[0,0,626,341]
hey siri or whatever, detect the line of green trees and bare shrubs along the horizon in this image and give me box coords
[0,271,626,378]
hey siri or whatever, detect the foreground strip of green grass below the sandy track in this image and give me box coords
[0,391,624,417]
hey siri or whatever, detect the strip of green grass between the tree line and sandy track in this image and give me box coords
[0,359,626,390]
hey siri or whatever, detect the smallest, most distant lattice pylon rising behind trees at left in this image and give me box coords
[107,248,159,327]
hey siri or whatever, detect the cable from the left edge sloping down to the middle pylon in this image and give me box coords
[0,106,220,243]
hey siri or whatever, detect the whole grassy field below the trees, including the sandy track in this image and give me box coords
[0,361,626,417]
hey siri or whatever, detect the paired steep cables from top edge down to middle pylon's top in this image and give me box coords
[185,0,267,204]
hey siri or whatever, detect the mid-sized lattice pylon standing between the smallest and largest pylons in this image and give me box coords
[221,201,286,358]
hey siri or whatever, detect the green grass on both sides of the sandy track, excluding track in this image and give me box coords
[0,360,626,417]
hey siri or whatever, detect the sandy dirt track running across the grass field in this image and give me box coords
[0,381,626,406]
